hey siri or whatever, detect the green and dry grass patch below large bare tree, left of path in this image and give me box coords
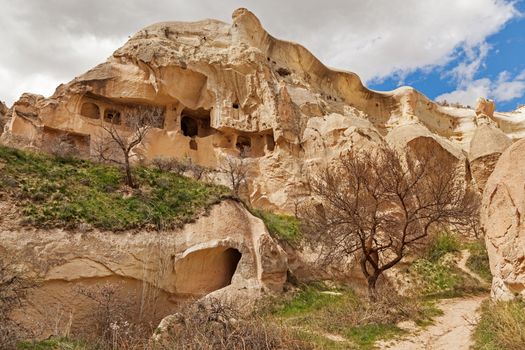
[266,284,402,349]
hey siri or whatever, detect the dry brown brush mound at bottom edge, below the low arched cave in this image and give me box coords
[157,299,308,350]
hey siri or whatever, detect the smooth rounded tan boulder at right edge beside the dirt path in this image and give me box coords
[481,139,525,300]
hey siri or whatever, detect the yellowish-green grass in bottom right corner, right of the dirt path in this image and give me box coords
[473,300,525,350]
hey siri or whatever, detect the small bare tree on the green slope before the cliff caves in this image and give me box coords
[94,105,164,187]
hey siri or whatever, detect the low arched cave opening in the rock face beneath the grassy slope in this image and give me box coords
[175,247,242,295]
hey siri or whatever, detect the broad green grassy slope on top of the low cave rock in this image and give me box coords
[0,146,229,230]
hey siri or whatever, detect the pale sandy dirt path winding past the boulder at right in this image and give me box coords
[377,250,487,350]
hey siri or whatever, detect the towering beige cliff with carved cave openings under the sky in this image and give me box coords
[2,9,525,211]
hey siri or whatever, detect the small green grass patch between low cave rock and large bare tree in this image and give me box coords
[250,209,301,243]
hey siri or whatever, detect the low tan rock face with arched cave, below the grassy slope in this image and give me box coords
[0,201,287,337]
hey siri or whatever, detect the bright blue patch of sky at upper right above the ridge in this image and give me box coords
[367,0,525,111]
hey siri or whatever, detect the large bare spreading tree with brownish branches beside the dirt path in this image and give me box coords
[300,147,478,298]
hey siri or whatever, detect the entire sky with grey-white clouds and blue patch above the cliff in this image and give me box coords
[0,0,525,110]
